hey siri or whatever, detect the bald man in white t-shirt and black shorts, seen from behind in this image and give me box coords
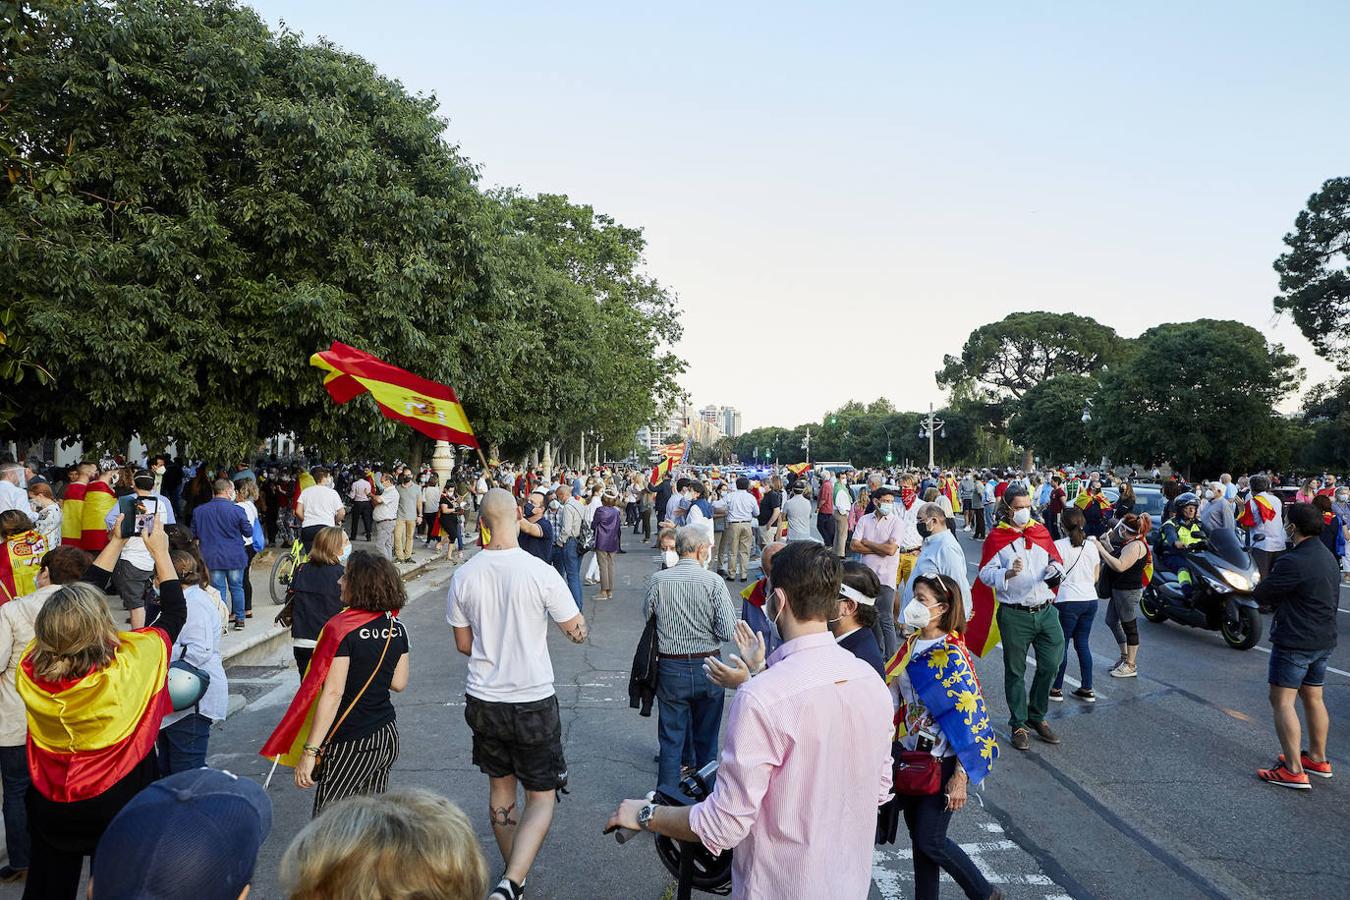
[446,488,587,900]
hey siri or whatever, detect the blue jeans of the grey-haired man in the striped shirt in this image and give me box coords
[656,660,725,788]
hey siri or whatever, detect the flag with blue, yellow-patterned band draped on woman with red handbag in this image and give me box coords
[886,634,999,784]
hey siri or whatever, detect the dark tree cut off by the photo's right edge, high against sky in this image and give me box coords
[1274,178,1350,370]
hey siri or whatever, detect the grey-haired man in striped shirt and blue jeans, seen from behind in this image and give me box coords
[643,525,736,787]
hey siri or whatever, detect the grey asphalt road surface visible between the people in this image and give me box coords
[0,536,1350,900]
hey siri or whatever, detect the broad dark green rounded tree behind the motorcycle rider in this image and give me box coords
[1091,318,1303,475]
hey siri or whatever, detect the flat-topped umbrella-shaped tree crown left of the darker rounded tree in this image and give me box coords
[937,312,1126,399]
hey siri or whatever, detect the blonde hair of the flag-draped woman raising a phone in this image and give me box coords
[32,582,119,681]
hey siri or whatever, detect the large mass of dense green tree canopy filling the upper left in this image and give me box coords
[0,0,683,457]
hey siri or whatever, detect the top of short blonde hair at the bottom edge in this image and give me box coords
[281,788,487,900]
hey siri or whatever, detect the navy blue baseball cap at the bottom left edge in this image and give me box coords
[90,768,271,900]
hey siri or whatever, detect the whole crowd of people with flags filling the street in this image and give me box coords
[0,456,1350,900]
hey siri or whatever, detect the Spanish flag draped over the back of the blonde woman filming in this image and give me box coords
[16,627,173,803]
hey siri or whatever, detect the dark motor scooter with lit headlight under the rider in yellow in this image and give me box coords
[1139,529,1261,650]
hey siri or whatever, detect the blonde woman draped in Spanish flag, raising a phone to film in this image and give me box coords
[18,515,188,900]
